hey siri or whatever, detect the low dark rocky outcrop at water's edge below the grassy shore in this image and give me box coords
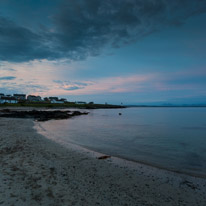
[0,109,88,121]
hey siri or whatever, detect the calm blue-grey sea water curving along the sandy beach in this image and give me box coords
[36,108,206,175]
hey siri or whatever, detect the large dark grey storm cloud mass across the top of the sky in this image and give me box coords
[0,0,206,62]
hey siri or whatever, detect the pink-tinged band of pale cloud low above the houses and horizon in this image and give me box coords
[0,57,206,102]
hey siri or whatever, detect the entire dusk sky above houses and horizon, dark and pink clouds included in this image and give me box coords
[0,0,206,104]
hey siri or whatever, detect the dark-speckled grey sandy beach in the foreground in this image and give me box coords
[0,117,206,206]
